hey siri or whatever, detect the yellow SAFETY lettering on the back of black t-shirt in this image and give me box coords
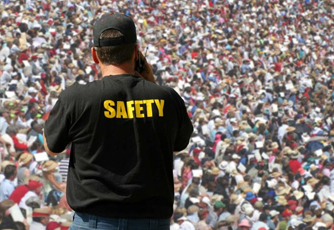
[103,99,165,119]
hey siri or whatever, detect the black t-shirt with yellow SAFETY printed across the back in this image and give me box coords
[45,74,193,218]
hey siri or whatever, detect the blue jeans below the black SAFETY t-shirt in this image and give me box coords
[69,212,170,230]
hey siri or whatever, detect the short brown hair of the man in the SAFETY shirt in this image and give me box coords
[94,29,136,65]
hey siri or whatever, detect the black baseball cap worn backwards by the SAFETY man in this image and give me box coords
[93,12,137,47]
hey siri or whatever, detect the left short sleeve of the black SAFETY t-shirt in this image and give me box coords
[44,99,71,153]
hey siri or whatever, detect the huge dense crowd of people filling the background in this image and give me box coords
[0,0,334,230]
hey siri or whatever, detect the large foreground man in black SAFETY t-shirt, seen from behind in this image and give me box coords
[44,12,193,230]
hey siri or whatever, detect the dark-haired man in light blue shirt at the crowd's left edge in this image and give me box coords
[0,164,17,202]
